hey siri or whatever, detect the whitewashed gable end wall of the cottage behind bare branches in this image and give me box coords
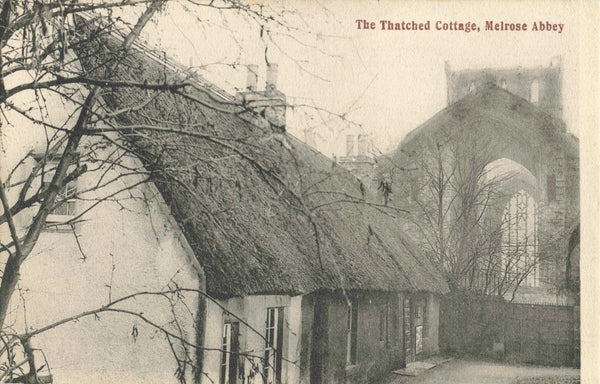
[1,87,200,384]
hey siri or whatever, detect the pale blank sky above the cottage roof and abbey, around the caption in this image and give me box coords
[126,0,579,156]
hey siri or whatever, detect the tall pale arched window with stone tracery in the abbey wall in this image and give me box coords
[502,190,539,287]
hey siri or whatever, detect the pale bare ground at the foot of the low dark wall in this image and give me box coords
[382,359,580,384]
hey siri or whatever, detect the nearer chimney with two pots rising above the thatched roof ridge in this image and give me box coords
[238,63,286,131]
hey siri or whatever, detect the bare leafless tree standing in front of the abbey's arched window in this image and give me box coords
[391,129,542,299]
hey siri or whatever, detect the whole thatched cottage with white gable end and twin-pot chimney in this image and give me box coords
[1,15,448,384]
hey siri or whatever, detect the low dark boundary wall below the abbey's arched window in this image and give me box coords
[440,292,579,366]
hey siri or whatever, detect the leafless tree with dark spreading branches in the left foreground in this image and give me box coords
[0,0,384,383]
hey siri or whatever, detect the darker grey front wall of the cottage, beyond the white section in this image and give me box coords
[300,292,403,383]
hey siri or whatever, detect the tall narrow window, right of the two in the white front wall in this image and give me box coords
[264,307,283,384]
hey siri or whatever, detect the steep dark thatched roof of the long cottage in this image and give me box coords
[75,18,448,298]
